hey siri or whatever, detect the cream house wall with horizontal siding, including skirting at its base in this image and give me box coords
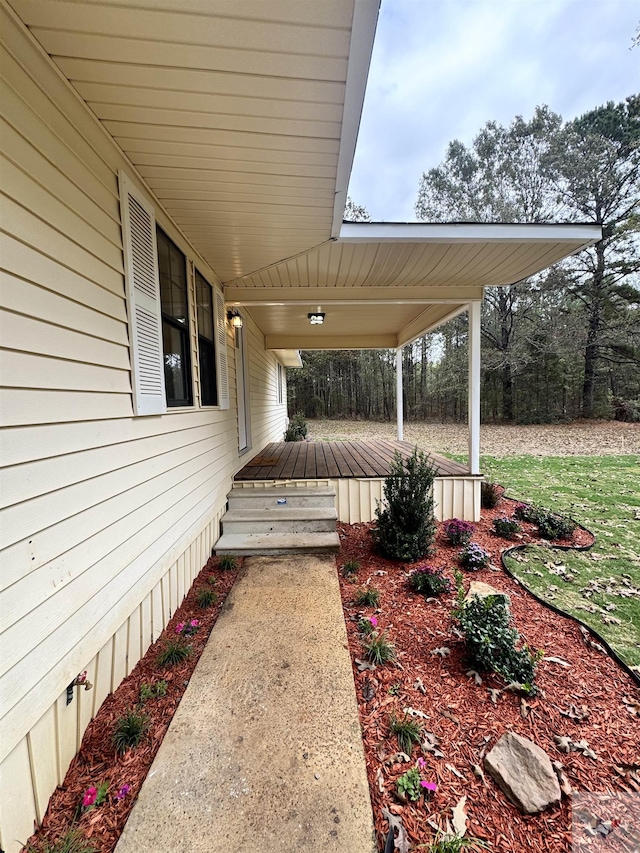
[0,11,286,853]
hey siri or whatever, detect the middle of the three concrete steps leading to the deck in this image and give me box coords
[222,506,338,533]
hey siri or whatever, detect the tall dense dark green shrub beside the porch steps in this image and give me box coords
[371,447,436,563]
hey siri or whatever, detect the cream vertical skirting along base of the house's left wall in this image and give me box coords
[0,506,224,853]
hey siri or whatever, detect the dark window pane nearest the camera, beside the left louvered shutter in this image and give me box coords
[156,228,193,406]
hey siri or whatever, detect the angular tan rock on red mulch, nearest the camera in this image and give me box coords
[484,732,560,814]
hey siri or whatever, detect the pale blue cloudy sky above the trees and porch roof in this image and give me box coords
[349,0,640,221]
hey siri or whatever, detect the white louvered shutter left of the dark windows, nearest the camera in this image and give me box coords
[118,172,167,415]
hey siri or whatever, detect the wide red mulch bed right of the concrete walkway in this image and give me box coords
[338,499,640,853]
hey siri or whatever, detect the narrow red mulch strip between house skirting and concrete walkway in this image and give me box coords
[23,558,242,853]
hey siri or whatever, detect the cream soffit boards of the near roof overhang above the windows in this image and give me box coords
[9,0,379,281]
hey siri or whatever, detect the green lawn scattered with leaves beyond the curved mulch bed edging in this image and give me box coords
[481,456,640,667]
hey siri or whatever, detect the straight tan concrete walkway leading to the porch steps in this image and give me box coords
[116,556,376,853]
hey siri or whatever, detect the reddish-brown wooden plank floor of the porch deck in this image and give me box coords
[235,440,470,480]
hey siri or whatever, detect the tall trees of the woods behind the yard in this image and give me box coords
[288,95,640,423]
